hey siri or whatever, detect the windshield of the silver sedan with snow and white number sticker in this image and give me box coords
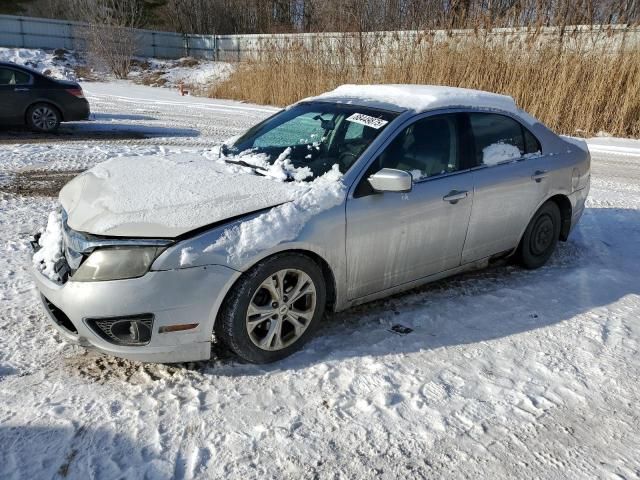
[223,102,397,180]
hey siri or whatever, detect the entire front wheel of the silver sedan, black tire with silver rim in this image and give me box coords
[214,253,326,363]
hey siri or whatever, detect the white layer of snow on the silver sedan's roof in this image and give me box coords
[304,84,520,113]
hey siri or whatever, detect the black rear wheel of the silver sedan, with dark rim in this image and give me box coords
[518,201,562,270]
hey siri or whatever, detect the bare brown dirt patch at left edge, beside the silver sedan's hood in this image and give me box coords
[0,170,83,197]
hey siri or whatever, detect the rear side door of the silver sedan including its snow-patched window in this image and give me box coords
[462,112,548,263]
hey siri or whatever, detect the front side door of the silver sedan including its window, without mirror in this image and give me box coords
[346,114,473,299]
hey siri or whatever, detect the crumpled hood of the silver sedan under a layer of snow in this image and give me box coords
[60,154,305,237]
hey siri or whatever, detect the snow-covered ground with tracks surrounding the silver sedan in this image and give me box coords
[0,83,640,479]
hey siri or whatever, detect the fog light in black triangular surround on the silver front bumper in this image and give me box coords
[86,314,153,346]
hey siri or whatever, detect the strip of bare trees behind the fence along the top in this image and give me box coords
[20,0,640,34]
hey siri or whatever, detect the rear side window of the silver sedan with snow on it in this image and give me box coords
[469,112,540,165]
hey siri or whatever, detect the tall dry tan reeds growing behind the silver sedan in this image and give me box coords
[209,31,640,137]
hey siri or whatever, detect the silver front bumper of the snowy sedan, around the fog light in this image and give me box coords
[32,266,237,363]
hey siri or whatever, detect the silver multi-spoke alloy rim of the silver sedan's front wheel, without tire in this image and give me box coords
[246,269,317,351]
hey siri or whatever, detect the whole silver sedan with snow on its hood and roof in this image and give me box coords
[32,85,590,363]
